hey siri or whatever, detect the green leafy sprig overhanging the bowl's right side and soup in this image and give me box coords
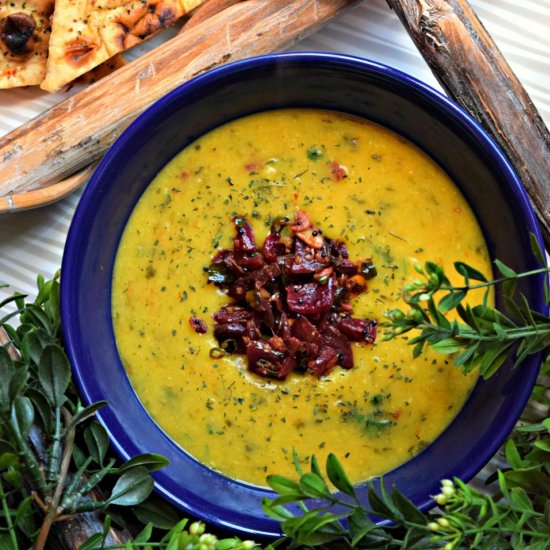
[381,236,550,378]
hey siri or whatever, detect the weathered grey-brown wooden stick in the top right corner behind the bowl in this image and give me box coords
[387,0,550,247]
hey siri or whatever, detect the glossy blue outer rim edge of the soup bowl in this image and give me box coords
[60,52,547,537]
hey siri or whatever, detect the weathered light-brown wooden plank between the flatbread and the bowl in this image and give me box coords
[0,0,357,213]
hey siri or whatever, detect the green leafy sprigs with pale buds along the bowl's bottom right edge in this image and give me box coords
[262,446,550,550]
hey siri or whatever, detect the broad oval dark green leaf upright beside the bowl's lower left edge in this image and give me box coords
[38,344,71,407]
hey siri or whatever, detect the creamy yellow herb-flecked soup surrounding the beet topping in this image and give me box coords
[112,110,490,484]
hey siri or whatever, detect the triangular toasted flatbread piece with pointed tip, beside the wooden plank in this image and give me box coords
[40,0,202,92]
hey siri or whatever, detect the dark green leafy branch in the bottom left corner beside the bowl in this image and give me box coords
[0,276,256,550]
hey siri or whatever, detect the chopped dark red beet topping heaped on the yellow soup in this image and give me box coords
[205,212,377,380]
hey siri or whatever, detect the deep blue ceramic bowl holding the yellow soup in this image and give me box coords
[61,53,544,537]
